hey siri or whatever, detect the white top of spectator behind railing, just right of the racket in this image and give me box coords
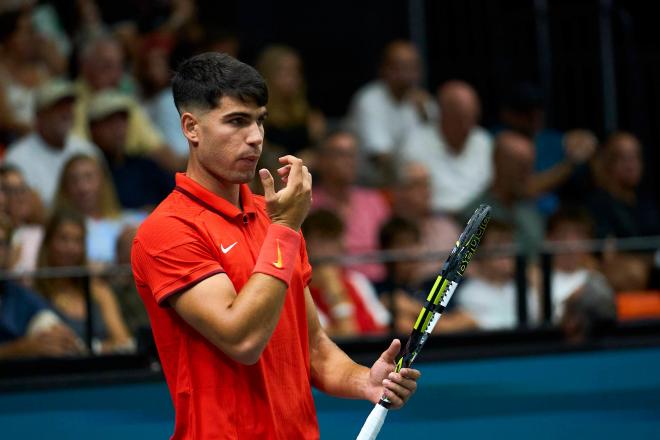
[456,277,539,330]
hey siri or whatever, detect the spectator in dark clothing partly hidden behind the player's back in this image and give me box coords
[110,225,149,335]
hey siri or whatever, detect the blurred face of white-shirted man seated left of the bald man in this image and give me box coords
[381,43,421,94]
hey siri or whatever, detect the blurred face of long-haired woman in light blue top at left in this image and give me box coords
[64,159,102,215]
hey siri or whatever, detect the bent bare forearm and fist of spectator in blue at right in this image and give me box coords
[529,129,598,197]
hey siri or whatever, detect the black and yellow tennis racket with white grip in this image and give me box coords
[357,205,490,440]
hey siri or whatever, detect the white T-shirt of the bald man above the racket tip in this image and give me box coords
[401,123,493,213]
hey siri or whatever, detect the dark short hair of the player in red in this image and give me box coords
[172,52,268,113]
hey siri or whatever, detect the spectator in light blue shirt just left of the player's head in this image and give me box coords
[137,34,188,158]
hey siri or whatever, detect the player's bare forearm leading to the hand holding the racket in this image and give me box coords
[310,332,369,399]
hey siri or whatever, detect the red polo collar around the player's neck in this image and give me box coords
[174,173,256,219]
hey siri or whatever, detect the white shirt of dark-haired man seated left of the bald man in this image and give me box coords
[347,81,438,154]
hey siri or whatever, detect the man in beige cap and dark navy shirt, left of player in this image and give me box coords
[88,91,174,211]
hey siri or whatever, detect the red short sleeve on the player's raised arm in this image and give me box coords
[131,239,224,305]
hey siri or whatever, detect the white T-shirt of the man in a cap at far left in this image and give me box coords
[5,133,100,207]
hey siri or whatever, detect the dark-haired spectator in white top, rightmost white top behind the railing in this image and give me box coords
[547,206,598,323]
